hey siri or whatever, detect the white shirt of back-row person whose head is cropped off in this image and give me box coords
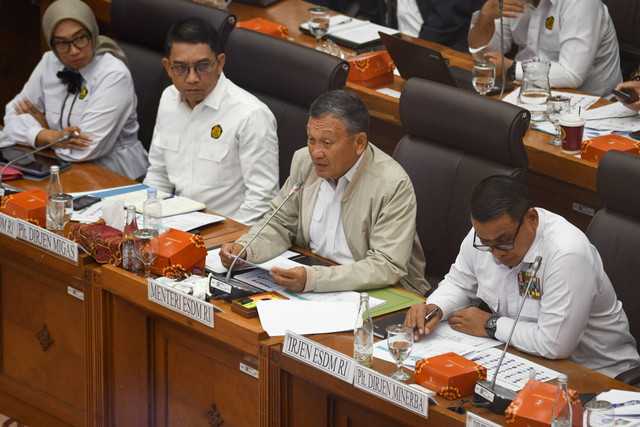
[470,0,622,96]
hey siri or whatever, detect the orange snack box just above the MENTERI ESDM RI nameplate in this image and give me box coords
[151,228,207,277]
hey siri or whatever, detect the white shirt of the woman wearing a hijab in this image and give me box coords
[4,51,149,179]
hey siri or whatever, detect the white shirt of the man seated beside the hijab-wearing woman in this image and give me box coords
[144,73,279,224]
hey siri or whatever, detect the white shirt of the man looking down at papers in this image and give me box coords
[427,209,640,377]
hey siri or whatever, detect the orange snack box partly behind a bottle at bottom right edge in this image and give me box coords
[504,380,582,427]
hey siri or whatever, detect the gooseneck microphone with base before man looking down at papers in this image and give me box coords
[474,255,542,414]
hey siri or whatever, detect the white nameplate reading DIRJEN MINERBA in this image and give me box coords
[353,365,429,418]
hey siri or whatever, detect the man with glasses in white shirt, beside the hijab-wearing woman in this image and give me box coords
[144,18,279,224]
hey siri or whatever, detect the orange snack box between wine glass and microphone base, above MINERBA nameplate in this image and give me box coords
[415,353,487,400]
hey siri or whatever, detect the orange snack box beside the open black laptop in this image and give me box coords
[347,50,395,87]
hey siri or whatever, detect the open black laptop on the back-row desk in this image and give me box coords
[380,33,513,95]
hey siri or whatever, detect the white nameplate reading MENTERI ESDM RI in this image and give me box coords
[148,279,213,328]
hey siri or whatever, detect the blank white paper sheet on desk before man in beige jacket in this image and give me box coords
[256,300,358,337]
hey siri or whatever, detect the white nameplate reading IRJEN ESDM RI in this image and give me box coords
[282,331,356,383]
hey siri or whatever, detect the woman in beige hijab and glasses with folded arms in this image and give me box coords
[4,0,149,178]
